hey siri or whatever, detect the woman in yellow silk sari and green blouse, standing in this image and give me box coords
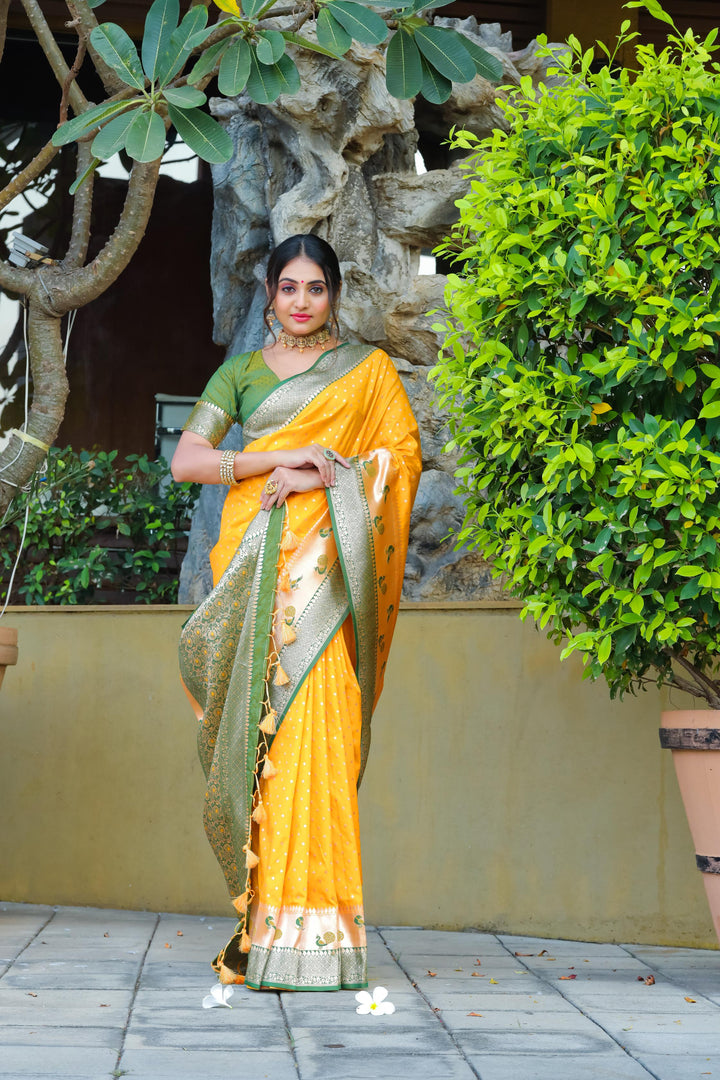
[173,235,420,990]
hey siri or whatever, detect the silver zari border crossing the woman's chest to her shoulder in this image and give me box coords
[243,345,377,446]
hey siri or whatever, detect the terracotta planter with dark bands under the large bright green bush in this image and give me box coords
[660,708,720,941]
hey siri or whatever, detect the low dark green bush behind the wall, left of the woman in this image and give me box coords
[0,448,200,604]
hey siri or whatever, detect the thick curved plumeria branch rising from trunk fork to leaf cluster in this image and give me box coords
[51,159,161,314]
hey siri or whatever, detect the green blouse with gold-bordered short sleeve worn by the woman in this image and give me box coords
[182,349,281,446]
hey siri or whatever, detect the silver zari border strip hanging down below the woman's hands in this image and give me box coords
[327,458,378,786]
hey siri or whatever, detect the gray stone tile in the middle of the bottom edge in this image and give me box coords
[293,1039,475,1080]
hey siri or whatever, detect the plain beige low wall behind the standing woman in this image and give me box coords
[0,605,715,946]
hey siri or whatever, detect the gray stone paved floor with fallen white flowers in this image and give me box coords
[0,904,720,1080]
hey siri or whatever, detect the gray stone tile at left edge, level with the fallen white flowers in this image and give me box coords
[0,980,132,1027]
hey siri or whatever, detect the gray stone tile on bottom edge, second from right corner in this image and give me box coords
[471,1051,656,1080]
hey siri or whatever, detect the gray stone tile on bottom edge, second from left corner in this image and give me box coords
[120,1049,298,1080]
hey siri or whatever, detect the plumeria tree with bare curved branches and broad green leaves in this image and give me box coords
[0,0,502,512]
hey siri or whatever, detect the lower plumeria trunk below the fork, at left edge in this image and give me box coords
[0,295,68,513]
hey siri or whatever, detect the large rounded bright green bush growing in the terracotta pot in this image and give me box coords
[434,8,720,707]
